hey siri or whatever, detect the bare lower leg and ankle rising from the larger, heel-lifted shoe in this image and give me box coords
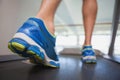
[36,0,61,35]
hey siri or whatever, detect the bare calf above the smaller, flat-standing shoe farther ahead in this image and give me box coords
[82,0,97,45]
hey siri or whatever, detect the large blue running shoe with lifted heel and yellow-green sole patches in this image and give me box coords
[8,18,60,68]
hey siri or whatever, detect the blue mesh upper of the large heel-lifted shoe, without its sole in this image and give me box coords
[17,18,58,61]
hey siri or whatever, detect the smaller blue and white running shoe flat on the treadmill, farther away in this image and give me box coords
[82,46,96,63]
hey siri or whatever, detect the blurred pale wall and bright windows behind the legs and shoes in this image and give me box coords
[0,0,120,56]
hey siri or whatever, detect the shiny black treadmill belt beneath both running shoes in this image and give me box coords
[0,55,120,80]
